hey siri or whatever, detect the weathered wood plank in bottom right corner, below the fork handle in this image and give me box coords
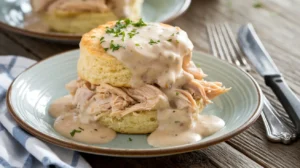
[228,118,300,167]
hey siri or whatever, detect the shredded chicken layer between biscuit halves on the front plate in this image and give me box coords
[66,48,229,119]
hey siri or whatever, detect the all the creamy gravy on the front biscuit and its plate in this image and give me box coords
[50,19,225,147]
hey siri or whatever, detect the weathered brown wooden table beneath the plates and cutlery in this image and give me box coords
[0,0,300,168]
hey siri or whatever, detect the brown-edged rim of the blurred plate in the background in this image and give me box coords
[0,0,192,42]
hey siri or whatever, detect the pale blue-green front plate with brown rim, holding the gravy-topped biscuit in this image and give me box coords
[7,50,262,157]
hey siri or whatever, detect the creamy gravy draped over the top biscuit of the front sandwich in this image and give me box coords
[101,23,193,88]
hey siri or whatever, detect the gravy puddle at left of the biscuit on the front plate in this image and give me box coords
[49,95,116,144]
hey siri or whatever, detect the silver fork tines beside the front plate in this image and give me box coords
[207,23,250,71]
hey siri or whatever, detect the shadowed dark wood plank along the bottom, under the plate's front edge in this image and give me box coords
[83,143,261,168]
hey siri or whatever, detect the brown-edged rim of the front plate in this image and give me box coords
[6,49,263,157]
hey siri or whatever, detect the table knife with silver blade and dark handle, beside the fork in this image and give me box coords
[238,24,300,135]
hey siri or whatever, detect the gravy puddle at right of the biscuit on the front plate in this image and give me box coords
[148,109,225,147]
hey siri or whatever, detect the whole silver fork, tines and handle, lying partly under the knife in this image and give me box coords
[207,23,296,144]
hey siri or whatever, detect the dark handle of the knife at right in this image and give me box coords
[265,75,300,135]
